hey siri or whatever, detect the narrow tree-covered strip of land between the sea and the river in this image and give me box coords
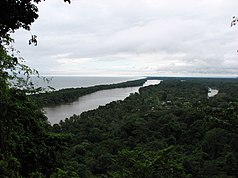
[31,79,147,106]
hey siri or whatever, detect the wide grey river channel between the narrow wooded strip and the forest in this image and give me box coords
[44,80,160,124]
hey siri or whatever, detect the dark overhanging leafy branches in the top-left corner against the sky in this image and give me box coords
[0,0,70,84]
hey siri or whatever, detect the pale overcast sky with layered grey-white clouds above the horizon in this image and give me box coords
[13,0,238,77]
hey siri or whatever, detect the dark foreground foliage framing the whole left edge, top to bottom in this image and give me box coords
[0,0,70,177]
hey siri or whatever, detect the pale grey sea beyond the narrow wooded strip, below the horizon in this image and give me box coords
[32,76,143,90]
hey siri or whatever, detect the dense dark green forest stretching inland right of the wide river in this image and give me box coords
[53,78,238,178]
